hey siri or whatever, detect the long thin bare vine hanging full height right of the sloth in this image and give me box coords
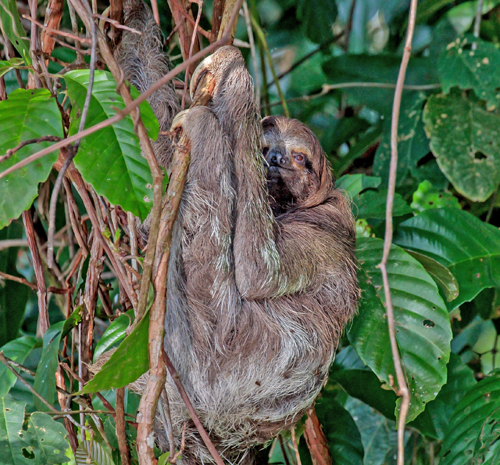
[379,0,417,465]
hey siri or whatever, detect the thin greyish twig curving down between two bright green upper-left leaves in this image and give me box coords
[47,15,97,268]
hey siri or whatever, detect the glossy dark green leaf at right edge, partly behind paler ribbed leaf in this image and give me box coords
[394,208,500,311]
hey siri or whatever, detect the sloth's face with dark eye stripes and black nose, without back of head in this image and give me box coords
[262,117,317,213]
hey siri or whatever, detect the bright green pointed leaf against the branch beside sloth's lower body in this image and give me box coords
[81,313,149,394]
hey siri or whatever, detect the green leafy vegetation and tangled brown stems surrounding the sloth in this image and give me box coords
[0,0,500,465]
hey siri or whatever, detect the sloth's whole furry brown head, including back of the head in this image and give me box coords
[262,116,333,214]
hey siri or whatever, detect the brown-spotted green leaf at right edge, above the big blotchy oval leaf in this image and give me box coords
[438,36,500,110]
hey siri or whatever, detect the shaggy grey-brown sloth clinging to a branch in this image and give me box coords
[117,0,359,464]
